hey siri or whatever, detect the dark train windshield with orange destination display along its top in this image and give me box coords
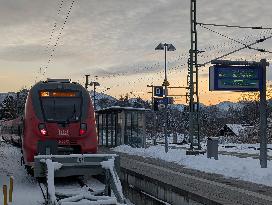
[40,92,81,123]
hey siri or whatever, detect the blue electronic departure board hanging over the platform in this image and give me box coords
[209,65,263,91]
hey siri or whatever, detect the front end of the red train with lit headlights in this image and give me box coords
[22,79,97,168]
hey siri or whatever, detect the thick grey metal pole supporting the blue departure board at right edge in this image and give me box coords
[259,59,267,168]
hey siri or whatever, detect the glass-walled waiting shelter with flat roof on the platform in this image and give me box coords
[96,106,147,147]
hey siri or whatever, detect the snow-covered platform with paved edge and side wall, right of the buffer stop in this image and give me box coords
[100,146,272,205]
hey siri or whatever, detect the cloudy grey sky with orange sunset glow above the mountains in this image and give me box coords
[0,0,272,104]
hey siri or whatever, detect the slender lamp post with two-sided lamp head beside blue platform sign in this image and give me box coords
[155,43,176,152]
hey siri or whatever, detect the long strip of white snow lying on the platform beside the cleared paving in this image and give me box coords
[113,145,272,186]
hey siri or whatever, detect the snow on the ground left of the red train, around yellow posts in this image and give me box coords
[0,142,43,205]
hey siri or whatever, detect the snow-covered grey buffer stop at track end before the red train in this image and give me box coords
[34,155,125,205]
